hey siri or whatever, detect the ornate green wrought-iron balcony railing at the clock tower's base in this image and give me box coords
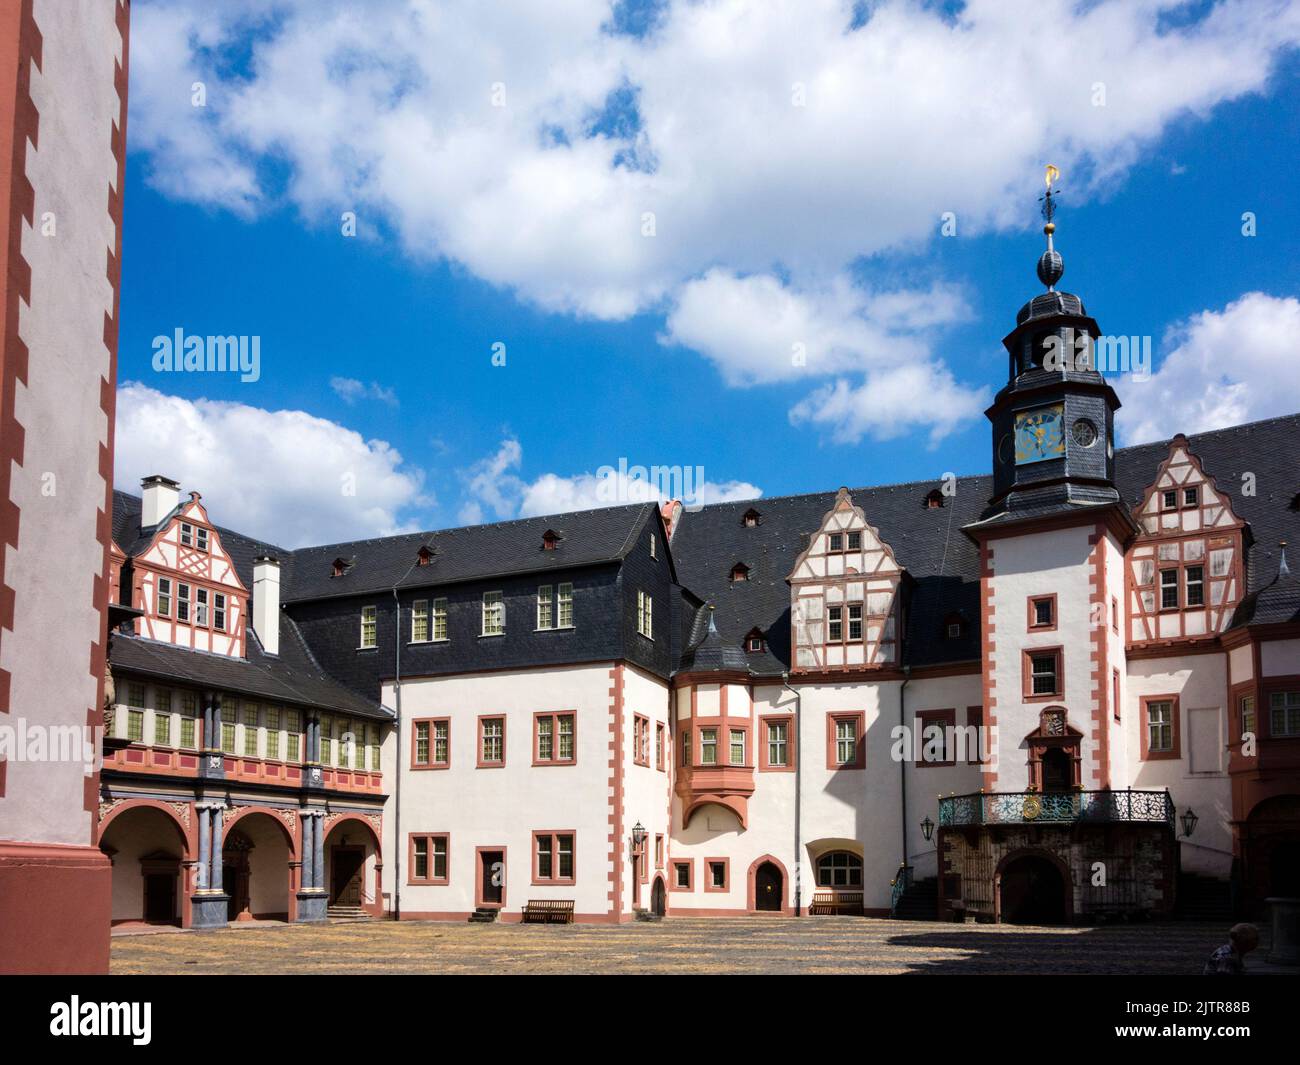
[939,789,1174,828]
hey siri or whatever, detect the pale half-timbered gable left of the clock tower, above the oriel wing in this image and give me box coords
[789,488,902,672]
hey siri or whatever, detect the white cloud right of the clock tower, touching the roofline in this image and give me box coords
[1115,293,1300,443]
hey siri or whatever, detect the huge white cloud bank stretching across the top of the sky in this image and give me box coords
[131,0,1300,319]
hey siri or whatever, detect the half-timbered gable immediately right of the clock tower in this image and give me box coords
[1127,434,1245,646]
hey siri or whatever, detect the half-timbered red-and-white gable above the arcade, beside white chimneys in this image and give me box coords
[133,492,248,657]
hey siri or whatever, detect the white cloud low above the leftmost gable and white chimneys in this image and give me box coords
[114,382,428,547]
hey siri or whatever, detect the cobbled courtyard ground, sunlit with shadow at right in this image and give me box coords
[112,917,1268,974]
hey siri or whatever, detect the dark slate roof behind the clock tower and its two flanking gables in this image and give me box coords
[672,415,1300,675]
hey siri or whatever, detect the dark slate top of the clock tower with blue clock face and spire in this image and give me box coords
[982,166,1119,524]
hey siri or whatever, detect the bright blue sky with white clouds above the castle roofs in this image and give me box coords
[117,0,1300,545]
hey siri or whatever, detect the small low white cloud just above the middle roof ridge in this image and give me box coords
[460,438,763,524]
